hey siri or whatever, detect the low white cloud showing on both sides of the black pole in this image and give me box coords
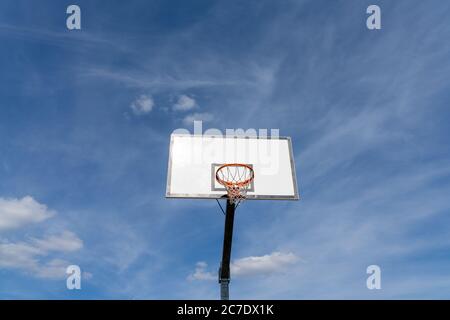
[188,252,299,281]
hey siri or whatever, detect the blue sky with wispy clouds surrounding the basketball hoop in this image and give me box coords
[0,0,450,299]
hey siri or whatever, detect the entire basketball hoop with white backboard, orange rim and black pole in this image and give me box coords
[166,132,299,300]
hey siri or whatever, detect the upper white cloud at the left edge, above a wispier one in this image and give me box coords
[0,196,54,231]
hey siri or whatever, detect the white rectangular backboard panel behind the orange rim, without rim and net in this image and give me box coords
[166,134,299,200]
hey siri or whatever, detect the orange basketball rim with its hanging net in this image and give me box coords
[216,163,255,204]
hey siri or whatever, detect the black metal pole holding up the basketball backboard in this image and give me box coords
[219,199,236,300]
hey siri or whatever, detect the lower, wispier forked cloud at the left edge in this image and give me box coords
[0,231,83,279]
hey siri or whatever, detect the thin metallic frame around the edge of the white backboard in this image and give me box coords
[165,133,300,201]
